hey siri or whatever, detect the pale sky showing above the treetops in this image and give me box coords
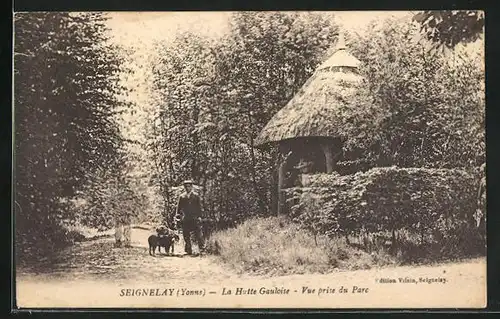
[103,11,411,104]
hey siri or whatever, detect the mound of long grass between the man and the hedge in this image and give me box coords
[207,217,396,275]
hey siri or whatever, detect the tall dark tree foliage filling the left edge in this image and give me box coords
[14,12,129,257]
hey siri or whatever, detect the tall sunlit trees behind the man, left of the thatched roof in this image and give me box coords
[148,13,336,228]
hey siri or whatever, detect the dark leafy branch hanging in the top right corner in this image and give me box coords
[413,10,484,48]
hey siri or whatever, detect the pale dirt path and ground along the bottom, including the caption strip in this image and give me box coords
[17,229,486,308]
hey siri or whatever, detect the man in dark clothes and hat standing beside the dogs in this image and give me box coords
[175,180,204,255]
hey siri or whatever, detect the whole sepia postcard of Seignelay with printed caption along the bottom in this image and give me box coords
[13,11,486,309]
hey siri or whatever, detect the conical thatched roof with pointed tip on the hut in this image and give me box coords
[256,36,362,145]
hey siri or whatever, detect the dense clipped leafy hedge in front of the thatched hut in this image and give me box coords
[292,167,485,258]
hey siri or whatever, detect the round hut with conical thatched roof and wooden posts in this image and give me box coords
[256,35,362,214]
